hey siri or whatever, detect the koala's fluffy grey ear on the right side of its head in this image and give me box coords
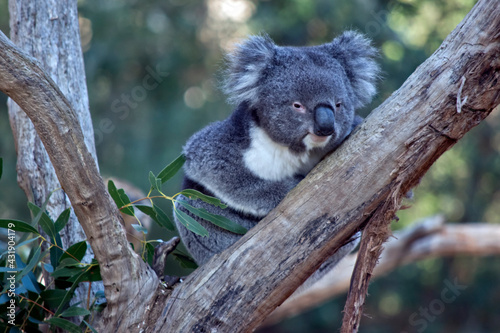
[325,31,380,108]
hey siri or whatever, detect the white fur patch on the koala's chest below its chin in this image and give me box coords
[243,127,322,181]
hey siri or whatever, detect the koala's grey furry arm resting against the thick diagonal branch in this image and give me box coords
[184,123,302,217]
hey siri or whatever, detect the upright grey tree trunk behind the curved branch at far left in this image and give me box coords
[8,0,98,304]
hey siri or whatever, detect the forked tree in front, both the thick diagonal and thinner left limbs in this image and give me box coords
[0,0,500,332]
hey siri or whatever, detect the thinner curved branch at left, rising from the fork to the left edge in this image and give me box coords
[0,32,158,332]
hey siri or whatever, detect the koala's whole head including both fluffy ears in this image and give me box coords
[224,31,379,152]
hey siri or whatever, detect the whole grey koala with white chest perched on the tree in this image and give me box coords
[176,31,379,269]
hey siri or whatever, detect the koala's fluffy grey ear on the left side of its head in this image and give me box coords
[222,35,276,104]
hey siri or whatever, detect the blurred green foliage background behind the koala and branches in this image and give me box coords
[0,0,500,332]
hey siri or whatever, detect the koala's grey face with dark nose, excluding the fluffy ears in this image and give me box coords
[253,48,354,152]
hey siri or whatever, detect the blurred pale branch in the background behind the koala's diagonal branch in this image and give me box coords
[263,217,500,325]
